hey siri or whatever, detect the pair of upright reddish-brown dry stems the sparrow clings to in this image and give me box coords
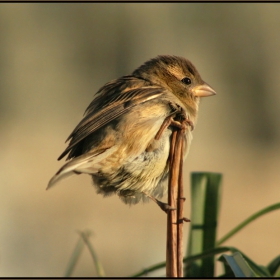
[165,112,190,277]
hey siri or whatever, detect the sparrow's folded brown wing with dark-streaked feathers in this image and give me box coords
[58,76,165,160]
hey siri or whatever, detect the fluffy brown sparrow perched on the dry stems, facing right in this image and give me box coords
[47,55,216,207]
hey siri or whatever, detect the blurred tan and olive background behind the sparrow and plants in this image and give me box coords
[0,3,280,277]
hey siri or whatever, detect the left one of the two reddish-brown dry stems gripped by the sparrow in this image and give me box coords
[166,130,178,277]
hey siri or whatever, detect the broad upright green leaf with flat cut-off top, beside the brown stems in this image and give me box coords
[185,172,222,277]
